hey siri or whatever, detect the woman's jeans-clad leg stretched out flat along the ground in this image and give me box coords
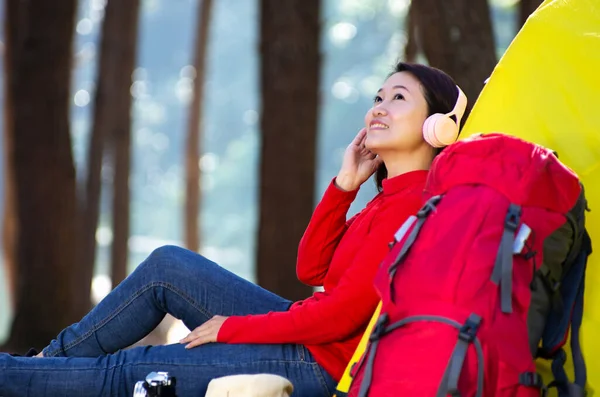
[0,343,335,397]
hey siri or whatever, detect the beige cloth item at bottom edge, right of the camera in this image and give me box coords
[205,374,294,397]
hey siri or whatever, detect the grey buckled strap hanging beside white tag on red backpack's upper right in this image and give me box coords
[491,203,521,313]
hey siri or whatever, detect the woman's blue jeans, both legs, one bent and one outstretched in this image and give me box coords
[0,246,336,397]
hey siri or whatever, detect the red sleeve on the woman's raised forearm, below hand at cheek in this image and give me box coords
[296,179,358,287]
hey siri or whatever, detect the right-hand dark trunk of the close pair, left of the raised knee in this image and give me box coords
[107,0,140,287]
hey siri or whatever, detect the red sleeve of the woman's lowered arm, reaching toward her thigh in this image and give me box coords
[217,206,418,344]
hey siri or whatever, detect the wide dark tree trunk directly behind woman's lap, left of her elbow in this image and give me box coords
[256,0,321,300]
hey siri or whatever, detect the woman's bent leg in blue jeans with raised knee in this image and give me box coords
[43,246,291,357]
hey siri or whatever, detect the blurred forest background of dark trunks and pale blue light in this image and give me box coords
[0,0,541,351]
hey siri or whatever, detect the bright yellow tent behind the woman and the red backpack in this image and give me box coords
[463,0,600,396]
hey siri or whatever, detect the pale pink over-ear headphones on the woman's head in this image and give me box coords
[423,86,467,148]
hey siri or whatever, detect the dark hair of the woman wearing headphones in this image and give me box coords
[375,62,469,191]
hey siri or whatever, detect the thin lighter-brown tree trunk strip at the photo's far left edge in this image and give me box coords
[2,0,20,310]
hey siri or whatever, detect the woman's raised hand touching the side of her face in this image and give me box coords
[335,128,381,191]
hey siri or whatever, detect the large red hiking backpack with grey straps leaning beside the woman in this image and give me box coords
[349,134,591,397]
